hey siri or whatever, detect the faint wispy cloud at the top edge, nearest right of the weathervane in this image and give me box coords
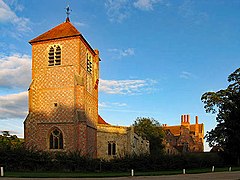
[105,0,130,23]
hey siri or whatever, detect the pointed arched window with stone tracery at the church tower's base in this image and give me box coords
[49,129,63,149]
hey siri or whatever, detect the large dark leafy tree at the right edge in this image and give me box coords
[201,68,240,165]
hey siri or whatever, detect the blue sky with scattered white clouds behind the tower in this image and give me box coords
[0,0,240,151]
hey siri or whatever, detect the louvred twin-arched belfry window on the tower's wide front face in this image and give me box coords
[48,45,61,66]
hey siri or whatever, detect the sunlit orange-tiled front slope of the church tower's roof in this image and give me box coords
[29,21,81,44]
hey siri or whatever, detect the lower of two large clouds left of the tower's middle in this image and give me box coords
[0,91,28,120]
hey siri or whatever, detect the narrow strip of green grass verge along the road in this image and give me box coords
[5,167,240,178]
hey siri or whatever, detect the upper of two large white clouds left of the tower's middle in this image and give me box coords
[0,54,31,89]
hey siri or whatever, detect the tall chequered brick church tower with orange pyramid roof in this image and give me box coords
[24,14,100,157]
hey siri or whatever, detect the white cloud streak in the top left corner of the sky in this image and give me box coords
[0,1,31,33]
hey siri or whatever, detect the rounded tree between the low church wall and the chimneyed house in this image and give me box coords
[133,118,164,155]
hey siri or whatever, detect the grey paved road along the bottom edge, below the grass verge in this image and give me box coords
[0,171,240,180]
